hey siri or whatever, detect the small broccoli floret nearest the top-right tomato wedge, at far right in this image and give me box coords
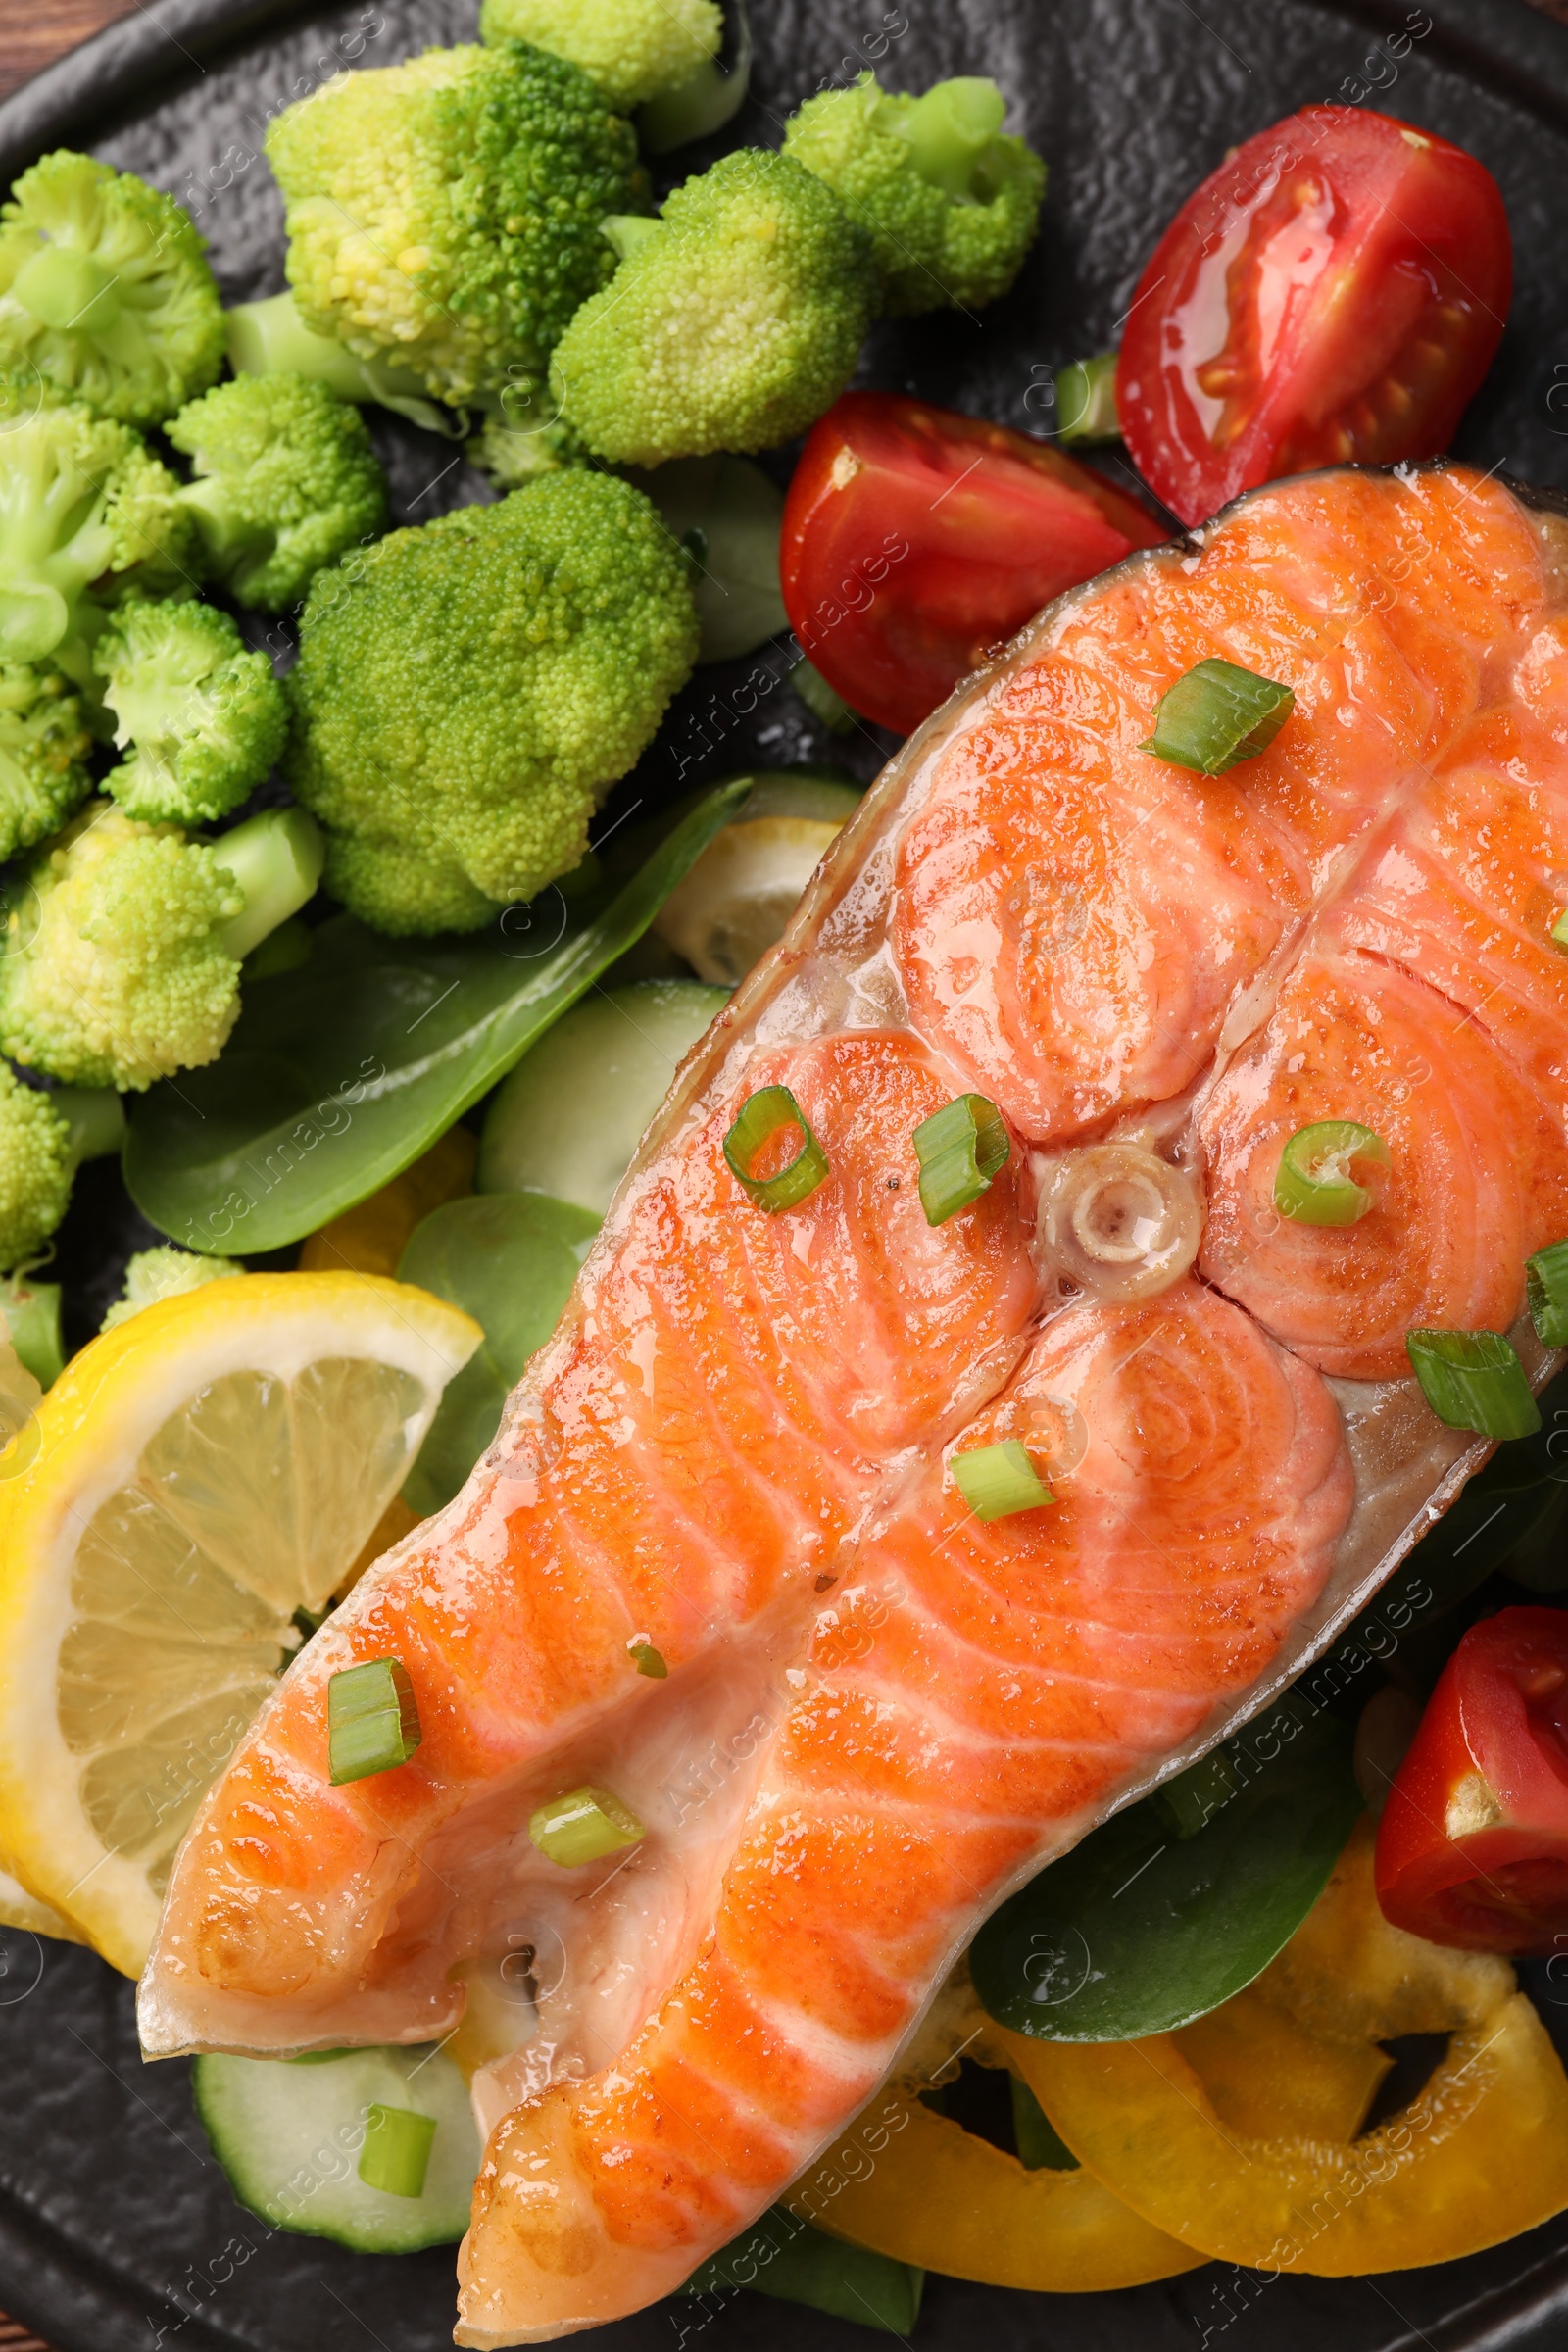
[783,73,1046,318]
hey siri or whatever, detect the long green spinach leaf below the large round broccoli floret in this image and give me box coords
[124,781,748,1256]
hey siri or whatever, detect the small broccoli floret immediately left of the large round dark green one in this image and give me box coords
[92,602,289,825]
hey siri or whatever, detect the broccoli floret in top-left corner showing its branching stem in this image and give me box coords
[0,148,223,425]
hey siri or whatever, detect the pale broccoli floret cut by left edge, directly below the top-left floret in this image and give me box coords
[0,402,193,684]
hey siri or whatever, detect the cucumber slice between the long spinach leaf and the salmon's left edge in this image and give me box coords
[477,981,729,1216]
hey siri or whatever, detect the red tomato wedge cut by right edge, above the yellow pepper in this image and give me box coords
[1378,1609,1568,1952]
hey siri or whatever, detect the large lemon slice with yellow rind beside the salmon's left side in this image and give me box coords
[0,1272,482,1976]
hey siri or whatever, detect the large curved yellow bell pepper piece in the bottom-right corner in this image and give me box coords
[1006,1823,1568,2277]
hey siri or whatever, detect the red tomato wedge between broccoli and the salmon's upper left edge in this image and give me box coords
[780,393,1168,734]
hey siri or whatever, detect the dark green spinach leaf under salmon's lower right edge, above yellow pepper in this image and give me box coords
[971,1700,1361,2041]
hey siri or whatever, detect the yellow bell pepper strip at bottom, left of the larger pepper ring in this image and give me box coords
[788,1985,1203,2295]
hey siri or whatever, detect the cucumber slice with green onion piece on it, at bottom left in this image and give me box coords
[190,2044,482,2253]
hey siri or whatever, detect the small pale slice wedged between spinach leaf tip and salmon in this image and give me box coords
[654,774,860,988]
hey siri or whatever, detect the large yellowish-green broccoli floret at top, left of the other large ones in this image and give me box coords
[266,40,647,402]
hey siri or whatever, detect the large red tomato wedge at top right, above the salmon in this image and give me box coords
[1116,106,1514,522]
